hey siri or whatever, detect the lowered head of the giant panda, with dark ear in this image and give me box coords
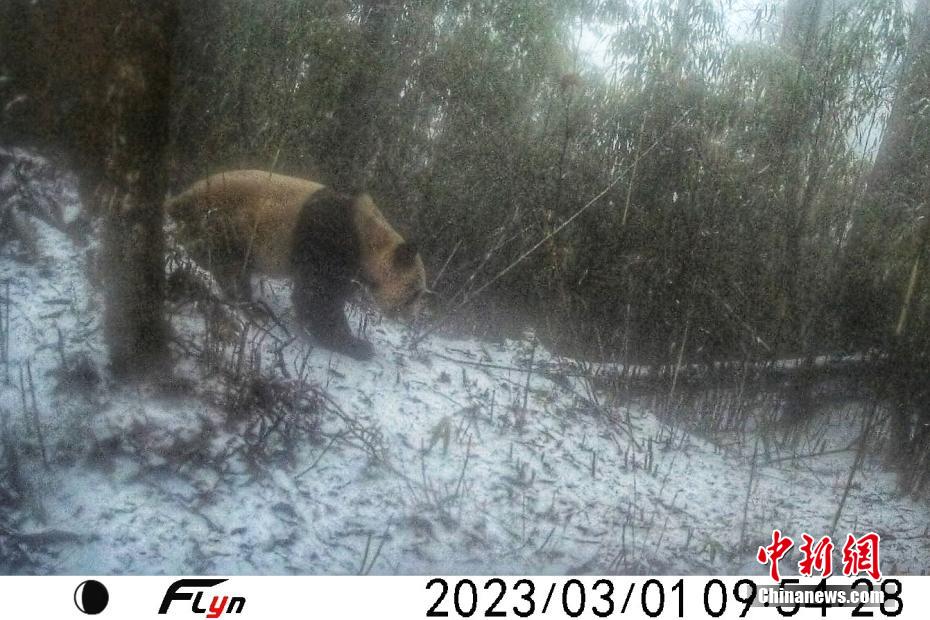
[370,241,427,320]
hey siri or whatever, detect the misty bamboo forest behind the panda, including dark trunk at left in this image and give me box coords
[0,0,930,502]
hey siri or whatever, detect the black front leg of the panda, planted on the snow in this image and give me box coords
[293,276,375,360]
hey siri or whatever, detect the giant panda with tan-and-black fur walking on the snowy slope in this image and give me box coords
[166,170,426,360]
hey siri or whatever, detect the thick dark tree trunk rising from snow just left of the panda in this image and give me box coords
[96,0,177,375]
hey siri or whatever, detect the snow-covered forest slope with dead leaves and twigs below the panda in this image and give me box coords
[0,156,930,574]
